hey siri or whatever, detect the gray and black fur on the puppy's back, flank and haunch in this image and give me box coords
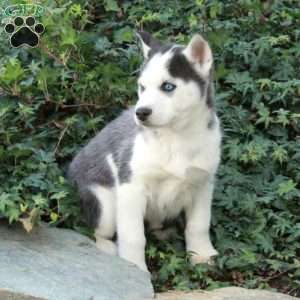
[68,109,138,226]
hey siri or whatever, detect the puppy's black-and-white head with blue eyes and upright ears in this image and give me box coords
[135,32,213,127]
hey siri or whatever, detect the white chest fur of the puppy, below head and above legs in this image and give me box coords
[131,119,221,224]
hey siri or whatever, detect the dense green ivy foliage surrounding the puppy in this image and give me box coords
[0,0,300,296]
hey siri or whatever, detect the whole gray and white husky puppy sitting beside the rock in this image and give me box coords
[69,32,221,270]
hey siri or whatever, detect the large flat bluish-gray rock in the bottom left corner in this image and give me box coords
[0,223,153,300]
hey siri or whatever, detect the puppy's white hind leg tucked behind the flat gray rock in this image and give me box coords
[85,185,117,255]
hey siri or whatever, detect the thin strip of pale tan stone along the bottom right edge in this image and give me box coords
[155,287,299,300]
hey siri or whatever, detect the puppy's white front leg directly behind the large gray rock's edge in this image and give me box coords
[117,183,148,271]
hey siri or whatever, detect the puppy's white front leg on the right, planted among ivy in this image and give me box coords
[185,179,218,264]
